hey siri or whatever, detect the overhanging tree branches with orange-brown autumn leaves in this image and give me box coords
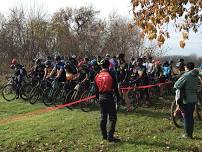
[131,0,202,48]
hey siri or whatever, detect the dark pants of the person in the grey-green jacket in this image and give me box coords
[183,103,195,137]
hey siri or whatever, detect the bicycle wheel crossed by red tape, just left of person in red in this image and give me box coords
[80,91,96,112]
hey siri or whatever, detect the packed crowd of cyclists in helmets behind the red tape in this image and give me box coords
[6,54,188,111]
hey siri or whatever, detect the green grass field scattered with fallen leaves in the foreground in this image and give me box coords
[0,98,202,152]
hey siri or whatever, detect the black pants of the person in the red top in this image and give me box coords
[100,98,117,138]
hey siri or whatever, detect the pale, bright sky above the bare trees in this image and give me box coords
[0,0,202,56]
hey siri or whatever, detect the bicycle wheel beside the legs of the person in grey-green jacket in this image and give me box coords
[170,101,184,128]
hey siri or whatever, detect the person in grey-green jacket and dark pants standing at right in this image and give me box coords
[174,62,200,138]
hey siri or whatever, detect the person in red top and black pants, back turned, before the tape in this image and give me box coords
[95,59,120,142]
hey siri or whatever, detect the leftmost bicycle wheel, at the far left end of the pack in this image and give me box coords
[2,84,17,101]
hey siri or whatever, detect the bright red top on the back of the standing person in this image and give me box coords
[95,71,113,93]
